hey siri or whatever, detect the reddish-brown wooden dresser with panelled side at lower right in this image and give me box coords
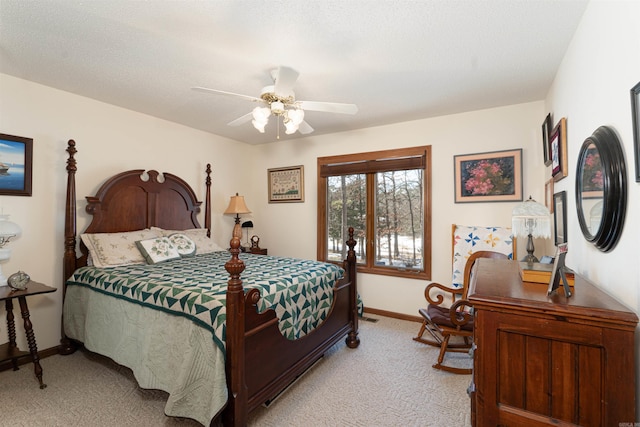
[469,259,638,427]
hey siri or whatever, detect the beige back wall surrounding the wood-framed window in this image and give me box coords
[247,101,546,315]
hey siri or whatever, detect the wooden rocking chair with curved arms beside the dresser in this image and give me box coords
[414,251,508,374]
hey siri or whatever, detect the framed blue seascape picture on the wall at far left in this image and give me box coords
[0,133,33,196]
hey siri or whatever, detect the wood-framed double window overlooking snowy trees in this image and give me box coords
[318,146,431,280]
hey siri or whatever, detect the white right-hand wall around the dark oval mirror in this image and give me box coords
[546,1,640,412]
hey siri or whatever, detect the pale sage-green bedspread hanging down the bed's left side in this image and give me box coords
[63,286,227,426]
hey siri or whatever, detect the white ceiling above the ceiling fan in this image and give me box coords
[0,0,587,144]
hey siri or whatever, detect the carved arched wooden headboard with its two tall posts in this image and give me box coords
[64,140,211,281]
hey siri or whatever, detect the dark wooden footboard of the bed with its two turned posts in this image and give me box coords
[223,232,360,426]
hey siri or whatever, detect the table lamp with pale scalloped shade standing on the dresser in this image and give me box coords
[511,196,551,263]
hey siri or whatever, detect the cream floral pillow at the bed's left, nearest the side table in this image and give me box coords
[80,228,161,268]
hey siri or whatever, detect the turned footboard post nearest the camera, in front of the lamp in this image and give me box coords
[223,236,249,426]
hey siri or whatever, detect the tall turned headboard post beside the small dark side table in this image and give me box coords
[59,139,77,354]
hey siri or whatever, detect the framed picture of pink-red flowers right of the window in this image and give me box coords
[453,149,522,203]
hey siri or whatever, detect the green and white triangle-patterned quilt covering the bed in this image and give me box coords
[67,252,344,351]
